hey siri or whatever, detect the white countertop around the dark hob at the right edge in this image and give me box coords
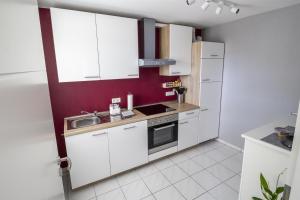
[242,116,297,154]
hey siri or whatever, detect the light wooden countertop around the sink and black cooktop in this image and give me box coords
[64,101,199,137]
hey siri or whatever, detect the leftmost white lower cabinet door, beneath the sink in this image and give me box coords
[66,130,110,189]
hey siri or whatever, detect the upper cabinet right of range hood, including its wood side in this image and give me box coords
[160,24,193,76]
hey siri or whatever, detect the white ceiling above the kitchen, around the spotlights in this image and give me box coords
[38,0,300,28]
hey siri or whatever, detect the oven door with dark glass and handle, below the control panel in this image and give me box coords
[148,121,178,155]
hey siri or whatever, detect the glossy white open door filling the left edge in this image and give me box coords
[0,0,64,200]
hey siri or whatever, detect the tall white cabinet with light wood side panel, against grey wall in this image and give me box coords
[181,42,224,142]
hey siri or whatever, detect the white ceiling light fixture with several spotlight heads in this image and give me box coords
[186,0,240,15]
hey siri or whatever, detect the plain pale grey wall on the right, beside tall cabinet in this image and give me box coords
[203,5,300,147]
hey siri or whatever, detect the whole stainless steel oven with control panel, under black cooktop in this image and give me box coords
[148,114,178,155]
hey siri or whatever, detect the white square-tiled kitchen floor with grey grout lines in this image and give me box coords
[71,141,242,200]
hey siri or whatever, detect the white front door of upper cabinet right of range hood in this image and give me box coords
[170,24,193,76]
